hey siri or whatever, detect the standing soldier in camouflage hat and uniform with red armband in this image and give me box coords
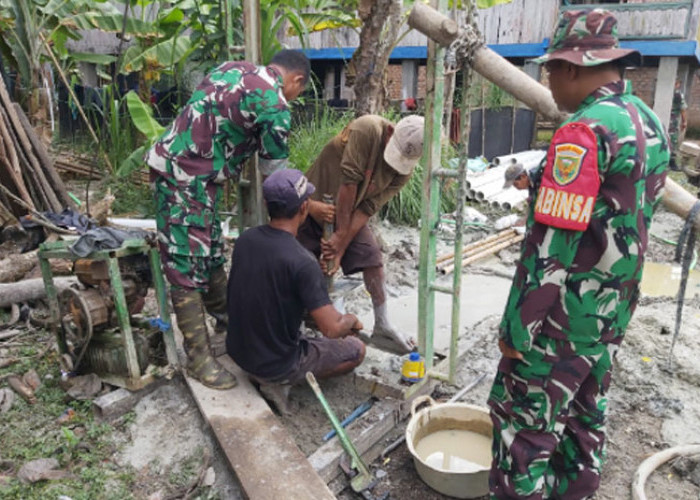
[489,9,669,500]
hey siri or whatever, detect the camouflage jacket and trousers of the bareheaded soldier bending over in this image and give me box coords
[146,62,290,291]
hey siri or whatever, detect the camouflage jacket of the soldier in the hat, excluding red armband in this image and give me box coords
[499,81,669,352]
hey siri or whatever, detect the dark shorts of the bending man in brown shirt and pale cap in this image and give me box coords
[297,217,382,275]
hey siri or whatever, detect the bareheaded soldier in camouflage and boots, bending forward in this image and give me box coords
[146,50,310,389]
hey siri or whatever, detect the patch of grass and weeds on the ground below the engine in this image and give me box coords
[0,331,133,500]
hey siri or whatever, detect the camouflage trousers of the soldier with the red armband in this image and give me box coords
[488,335,622,500]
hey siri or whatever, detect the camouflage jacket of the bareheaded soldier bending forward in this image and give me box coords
[145,61,290,207]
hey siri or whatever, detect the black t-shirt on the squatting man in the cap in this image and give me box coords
[226,225,331,378]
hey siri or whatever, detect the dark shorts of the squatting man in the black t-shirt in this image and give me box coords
[267,337,364,384]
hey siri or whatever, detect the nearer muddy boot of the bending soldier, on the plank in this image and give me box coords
[170,288,236,389]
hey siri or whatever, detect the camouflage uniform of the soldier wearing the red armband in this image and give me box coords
[488,8,669,499]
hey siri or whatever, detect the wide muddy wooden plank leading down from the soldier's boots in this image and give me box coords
[185,356,335,500]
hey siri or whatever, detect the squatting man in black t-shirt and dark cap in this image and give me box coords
[226,169,365,413]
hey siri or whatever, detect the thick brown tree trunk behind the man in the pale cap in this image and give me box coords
[346,0,402,116]
